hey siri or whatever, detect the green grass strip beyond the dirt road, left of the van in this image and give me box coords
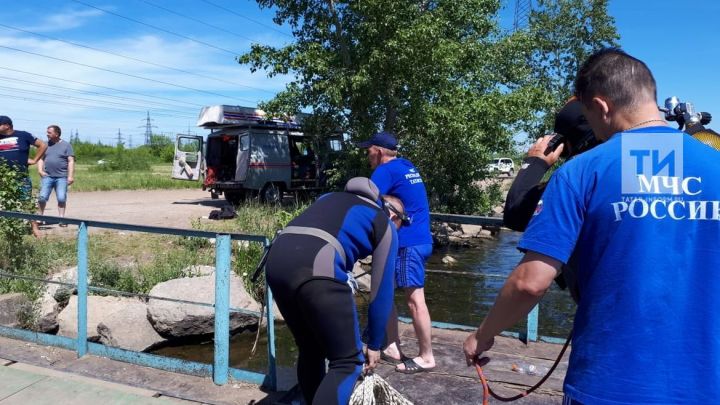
[30,164,201,192]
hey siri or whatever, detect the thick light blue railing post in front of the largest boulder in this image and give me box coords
[213,235,231,385]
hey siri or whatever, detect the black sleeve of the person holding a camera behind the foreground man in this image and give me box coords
[503,157,550,232]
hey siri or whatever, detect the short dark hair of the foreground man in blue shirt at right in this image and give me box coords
[575,48,657,108]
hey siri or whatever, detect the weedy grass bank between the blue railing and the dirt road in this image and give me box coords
[0,202,306,325]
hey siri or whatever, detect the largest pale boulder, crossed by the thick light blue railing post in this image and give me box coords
[148,275,260,337]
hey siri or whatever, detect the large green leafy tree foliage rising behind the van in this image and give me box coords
[238,0,614,213]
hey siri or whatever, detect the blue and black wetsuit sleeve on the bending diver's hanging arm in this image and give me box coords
[368,221,398,350]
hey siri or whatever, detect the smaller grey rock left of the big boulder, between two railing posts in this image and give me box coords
[97,297,165,352]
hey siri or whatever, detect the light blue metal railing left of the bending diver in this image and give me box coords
[0,211,277,390]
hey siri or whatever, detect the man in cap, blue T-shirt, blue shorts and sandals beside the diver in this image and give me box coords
[357,131,435,374]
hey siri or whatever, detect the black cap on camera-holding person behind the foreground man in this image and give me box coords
[553,98,598,155]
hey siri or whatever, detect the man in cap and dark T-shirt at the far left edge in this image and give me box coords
[0,115,47,236]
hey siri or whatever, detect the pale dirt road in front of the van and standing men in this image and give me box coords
[41,189,226,233]
